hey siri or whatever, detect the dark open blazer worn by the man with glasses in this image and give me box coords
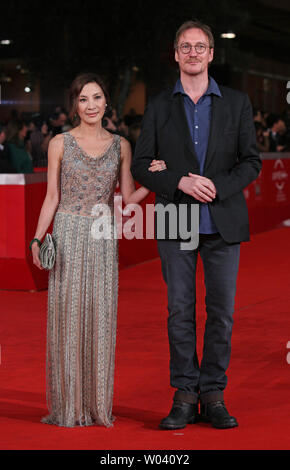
[131,86,261,243]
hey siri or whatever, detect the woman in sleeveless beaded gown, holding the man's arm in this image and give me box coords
[32,74,164,427]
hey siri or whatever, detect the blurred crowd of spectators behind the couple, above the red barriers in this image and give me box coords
[0,106,290,173]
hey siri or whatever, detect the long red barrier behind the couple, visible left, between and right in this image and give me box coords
[0,153,290,290]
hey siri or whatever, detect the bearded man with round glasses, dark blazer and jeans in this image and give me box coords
[131,21,261,429]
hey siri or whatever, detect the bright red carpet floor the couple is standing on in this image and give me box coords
[0,228,290,450]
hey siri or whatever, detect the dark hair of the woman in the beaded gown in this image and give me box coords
[69,73,110,126]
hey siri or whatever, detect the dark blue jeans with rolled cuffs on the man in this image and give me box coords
[158,234,240,403]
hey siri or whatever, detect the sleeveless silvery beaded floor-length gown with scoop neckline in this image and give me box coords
[42,132,120,427]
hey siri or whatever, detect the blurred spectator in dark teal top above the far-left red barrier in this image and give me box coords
[7,121,33,173]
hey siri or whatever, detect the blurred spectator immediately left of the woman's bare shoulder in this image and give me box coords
[27,116,52,167]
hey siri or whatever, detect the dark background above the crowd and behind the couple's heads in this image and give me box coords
[0,0,290,119]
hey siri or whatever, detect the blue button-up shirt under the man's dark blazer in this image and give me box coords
[173,77,222,233]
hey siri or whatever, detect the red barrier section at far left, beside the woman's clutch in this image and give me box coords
[0,173,47,290]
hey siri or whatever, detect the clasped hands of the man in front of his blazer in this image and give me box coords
[178,173,216,203]
